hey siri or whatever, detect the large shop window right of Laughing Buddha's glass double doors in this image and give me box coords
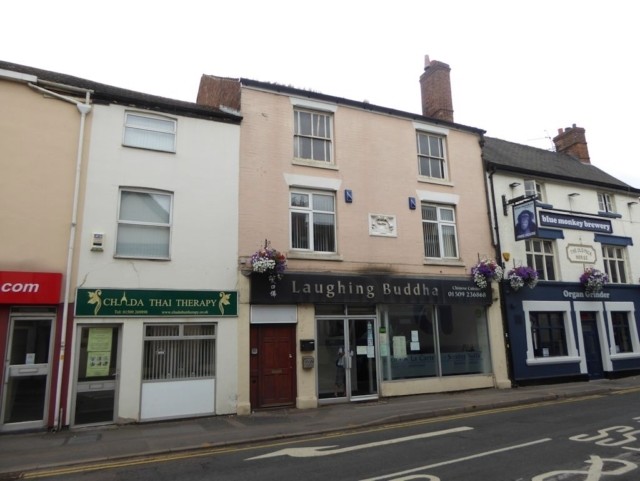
[380,305,491,380]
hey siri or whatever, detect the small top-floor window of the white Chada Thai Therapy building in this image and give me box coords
[123,112,177,152]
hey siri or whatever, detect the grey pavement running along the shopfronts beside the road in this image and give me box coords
[0,376,640,480]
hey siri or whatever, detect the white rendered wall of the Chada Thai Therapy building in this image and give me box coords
[70,105,240,422]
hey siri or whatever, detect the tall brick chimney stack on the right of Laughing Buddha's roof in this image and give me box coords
[420,55,453,122]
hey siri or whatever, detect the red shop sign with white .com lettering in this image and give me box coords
[0,271,62,304]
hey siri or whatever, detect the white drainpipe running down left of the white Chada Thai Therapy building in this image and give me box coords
[28,81,93,430]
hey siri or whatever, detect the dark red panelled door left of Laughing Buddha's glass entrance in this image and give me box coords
[251,324,296,408]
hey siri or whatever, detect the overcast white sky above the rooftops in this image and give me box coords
[5,0,640,188]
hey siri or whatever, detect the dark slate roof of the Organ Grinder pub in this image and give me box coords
[482,137,640,195]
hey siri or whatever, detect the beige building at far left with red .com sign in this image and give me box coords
[0,62,91,431]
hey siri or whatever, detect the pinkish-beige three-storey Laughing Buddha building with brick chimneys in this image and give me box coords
[198,54,510,414]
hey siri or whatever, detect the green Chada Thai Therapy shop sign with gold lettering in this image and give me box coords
[75,288,238,317]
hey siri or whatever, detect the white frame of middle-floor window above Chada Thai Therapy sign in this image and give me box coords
[115,187,173,260]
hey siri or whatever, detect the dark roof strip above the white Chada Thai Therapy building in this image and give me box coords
[0,60,242,124]
